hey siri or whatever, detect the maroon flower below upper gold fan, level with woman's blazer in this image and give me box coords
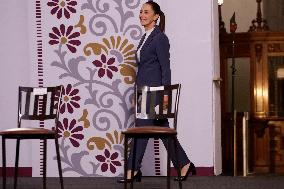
[93,54,118,79]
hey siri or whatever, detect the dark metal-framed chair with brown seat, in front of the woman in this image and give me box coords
[122,84,182,189]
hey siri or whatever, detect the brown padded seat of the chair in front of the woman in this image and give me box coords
[122,126,177,135]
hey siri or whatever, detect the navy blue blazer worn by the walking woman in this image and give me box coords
[136,26,171,86]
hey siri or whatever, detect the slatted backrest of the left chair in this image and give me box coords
[18,86,63,127]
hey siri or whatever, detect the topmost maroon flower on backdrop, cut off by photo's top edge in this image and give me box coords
[47,0,77,19]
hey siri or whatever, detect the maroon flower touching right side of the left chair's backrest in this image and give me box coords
[60,84,81,114]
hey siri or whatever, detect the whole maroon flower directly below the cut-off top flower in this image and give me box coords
[49,24,81,53]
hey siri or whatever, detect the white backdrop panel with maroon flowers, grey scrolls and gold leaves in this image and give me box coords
[28,0,164,176]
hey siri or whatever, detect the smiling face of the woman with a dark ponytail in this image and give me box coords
[139,3,159,30]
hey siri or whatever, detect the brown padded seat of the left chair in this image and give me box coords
[0,127,55,136]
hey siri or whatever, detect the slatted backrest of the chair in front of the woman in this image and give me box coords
[135,84,181,129]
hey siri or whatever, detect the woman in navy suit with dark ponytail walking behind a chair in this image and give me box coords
[118,1,196,183]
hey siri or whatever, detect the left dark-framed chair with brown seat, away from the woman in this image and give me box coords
[0,86,63,189]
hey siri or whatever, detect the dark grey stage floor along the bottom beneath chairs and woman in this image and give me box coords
[0,175,284,189]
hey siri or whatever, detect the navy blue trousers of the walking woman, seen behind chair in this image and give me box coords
[127,119,190,171]
